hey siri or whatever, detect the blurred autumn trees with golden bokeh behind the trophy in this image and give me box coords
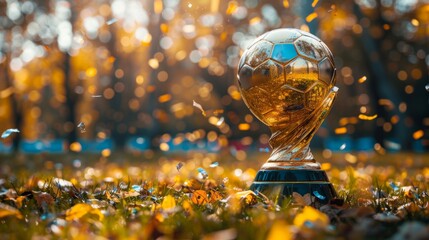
[0,0,429,154]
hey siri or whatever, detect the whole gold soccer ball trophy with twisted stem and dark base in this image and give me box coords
[238,28,338,204]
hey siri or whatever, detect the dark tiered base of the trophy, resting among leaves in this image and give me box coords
[250,169,337,205]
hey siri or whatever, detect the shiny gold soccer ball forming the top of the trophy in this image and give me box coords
[238,28,335,127]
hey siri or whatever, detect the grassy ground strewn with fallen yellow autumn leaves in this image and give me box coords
[0,153,429,239]
